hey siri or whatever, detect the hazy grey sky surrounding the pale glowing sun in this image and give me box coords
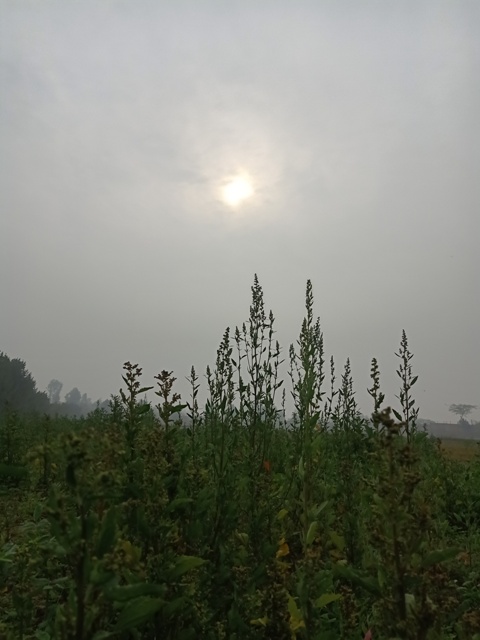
[0,0,480,421]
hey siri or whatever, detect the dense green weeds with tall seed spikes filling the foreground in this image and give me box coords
[0,278,480,640]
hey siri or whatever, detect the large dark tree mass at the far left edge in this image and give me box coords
[0,352,49,413]
